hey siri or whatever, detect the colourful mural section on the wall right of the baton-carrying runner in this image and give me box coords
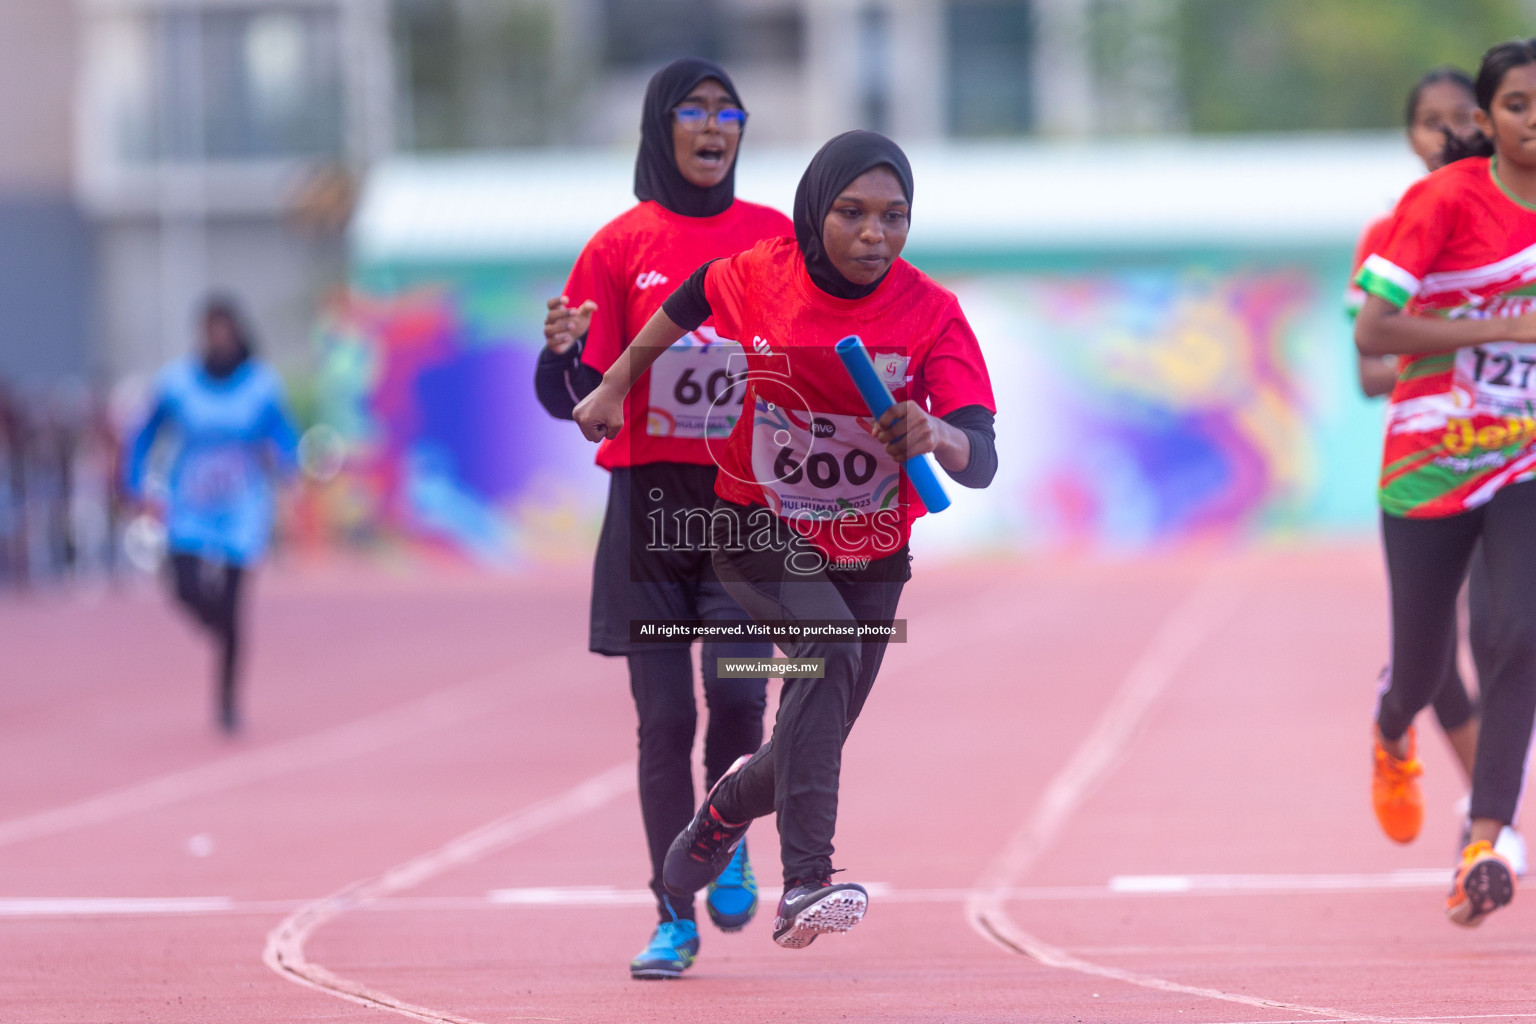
[921,263,1379,548]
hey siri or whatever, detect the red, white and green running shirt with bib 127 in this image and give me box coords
[1355,157,1536,519]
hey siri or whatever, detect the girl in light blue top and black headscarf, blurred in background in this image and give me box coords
[124,299,296,732]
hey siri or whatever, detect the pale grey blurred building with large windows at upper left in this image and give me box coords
[77,0,393,376]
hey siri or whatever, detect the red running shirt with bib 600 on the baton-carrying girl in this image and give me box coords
[705,238,997,560]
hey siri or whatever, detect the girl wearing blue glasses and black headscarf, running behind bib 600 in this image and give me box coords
[535,58,793,978]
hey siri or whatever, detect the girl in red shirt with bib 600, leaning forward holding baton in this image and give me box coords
[576,132,997,949]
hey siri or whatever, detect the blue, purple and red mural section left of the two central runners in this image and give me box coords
[305,286,601,567]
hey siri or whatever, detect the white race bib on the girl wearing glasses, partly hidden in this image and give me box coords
[645,327,746,439]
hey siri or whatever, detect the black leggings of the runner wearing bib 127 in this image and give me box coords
[1376,482,1536,824]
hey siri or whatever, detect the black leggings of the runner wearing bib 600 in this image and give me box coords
[713,502,911,889]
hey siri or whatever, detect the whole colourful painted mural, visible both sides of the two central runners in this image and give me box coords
[308,253,1379,565]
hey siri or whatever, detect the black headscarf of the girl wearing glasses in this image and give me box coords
[634,57,742,216]
